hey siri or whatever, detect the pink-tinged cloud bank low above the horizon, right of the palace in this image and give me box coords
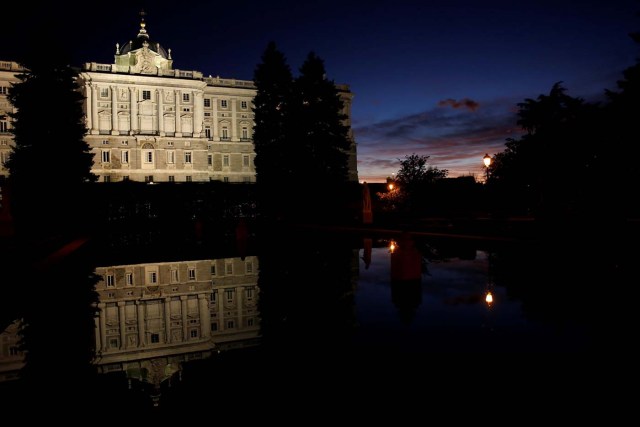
[353,99,521,182]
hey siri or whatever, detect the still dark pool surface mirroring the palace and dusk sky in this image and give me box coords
[0,223,616,411]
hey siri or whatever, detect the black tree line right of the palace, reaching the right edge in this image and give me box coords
[378,25,640,226]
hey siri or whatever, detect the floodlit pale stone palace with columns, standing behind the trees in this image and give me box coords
[0,19,358,182]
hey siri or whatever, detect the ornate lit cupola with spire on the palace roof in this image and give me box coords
[115,10,173,75]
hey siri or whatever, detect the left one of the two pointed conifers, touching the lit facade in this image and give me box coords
[253,41,293,187]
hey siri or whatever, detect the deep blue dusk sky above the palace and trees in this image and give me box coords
[5,0,640,182]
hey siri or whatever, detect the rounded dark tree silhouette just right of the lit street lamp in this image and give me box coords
[489,82,608,219]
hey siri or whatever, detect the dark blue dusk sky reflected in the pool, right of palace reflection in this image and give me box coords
[356,247,589,352]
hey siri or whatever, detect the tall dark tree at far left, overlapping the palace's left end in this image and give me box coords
[6,55,97,237]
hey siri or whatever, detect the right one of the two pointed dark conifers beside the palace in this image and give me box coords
[292,52,350,188]
